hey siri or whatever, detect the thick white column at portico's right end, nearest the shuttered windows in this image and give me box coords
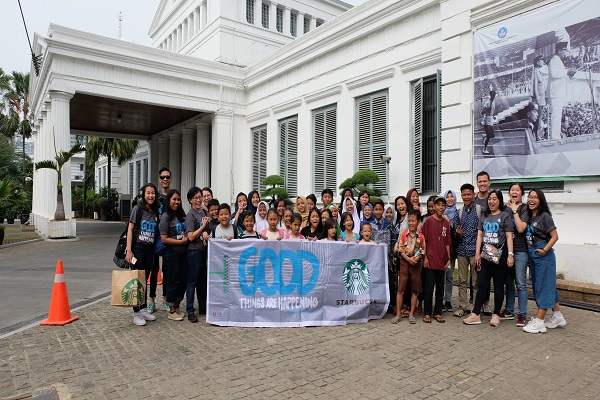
[210,112,234,203]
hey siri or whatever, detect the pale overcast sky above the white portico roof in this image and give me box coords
[0,0,366,73]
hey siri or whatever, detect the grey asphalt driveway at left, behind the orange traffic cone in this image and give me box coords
[0,221,123,334]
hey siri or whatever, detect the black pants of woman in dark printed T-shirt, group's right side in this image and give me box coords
[473,255,508,315]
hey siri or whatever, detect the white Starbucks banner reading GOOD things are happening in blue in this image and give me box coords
[206,239,389,327]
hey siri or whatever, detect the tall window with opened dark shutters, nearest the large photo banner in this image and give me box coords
[412,72,442,193]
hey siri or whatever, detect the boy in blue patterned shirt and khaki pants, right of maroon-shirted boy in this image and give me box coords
[454,183,481,317]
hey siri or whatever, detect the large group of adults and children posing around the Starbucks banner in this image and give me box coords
[125,168,566,333]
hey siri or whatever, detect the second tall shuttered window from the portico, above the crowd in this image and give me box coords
[279,115,298,198]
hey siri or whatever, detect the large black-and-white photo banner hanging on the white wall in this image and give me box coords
[473,0,600,178]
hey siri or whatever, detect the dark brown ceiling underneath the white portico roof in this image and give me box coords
[70,93,198,136]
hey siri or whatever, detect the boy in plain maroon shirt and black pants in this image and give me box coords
[421,197,451,323]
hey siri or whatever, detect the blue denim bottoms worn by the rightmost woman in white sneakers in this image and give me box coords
[529,242,558,310]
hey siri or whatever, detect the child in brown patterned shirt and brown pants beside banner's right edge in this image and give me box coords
[392,210,425,324]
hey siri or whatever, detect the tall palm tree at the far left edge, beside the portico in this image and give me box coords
[0,71,32,158]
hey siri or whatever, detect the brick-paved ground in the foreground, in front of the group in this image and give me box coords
[0,301,600,400]
